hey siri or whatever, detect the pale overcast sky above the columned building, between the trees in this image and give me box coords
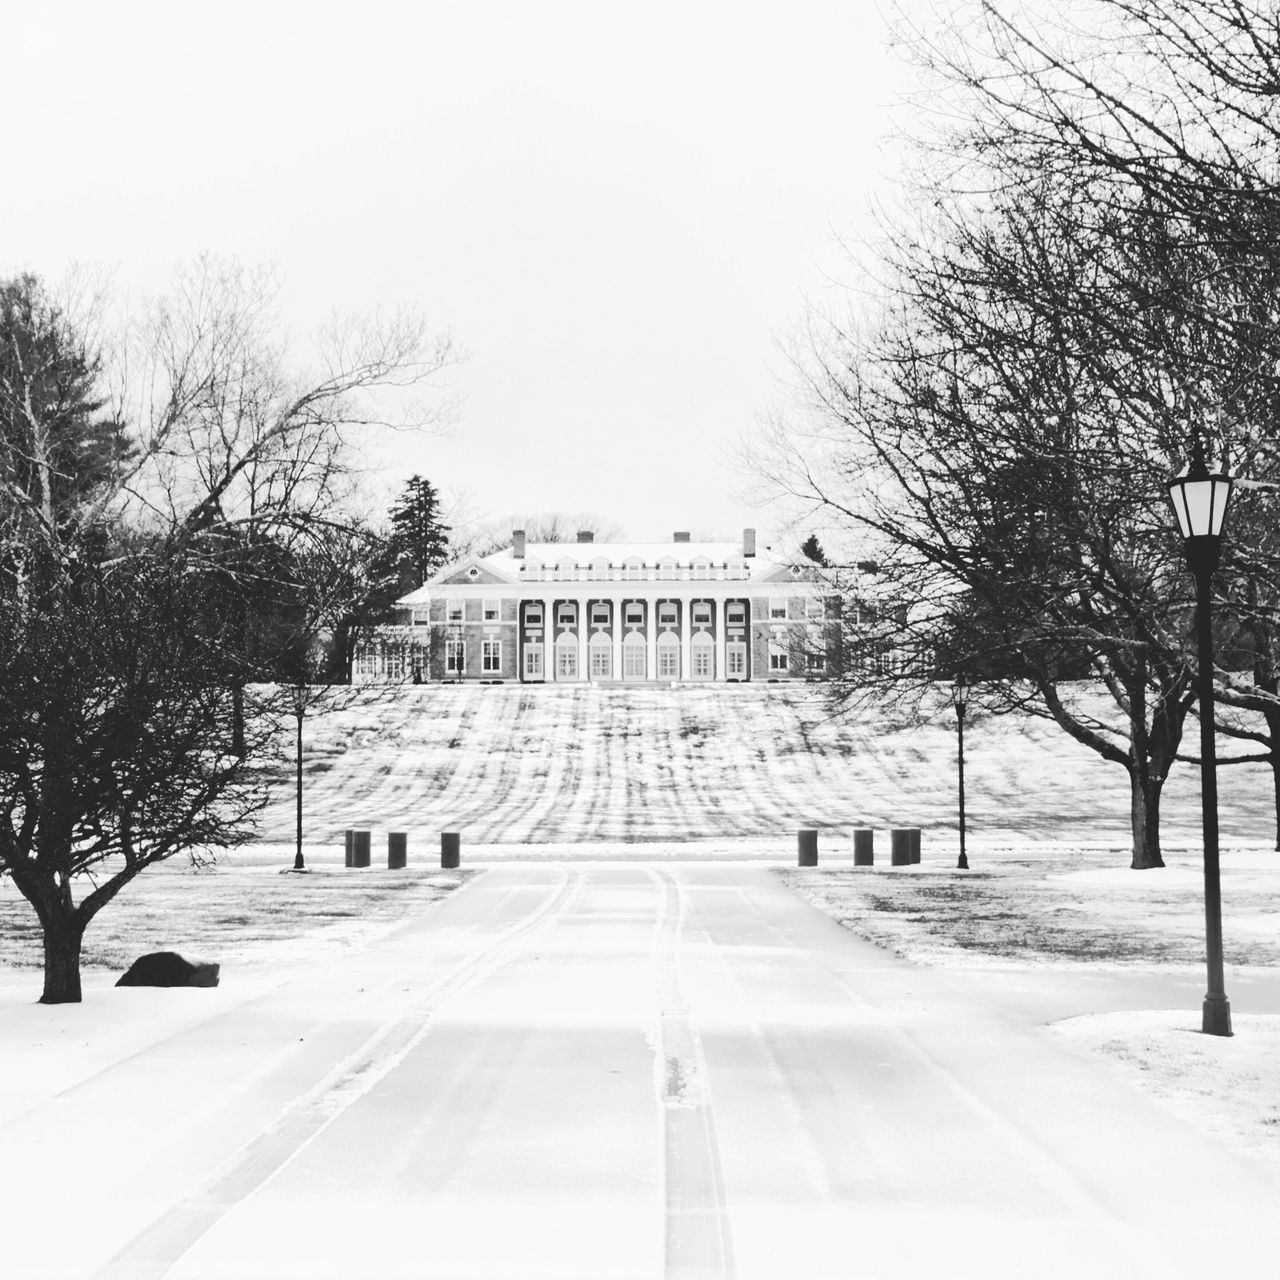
[0,0,908,550]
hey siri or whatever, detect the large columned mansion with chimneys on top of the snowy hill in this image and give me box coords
[353,529,838,684]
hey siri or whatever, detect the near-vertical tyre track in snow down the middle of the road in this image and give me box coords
[646,867,733,1280]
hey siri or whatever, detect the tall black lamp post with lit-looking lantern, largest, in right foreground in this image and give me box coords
[1169,436,1231,1036]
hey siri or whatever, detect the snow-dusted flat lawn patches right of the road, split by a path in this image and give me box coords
[778,842,1280,1161]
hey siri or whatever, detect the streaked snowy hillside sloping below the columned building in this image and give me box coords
[254,685,1274,846]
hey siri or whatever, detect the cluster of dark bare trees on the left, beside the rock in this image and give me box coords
[0,260,452,1002]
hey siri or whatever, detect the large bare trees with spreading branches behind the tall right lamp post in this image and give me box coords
[759,0,1280,867]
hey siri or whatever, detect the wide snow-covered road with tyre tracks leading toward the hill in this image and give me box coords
[0,863,1280,1280]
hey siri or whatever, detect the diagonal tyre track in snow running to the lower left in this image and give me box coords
[93,867,582,1280]
